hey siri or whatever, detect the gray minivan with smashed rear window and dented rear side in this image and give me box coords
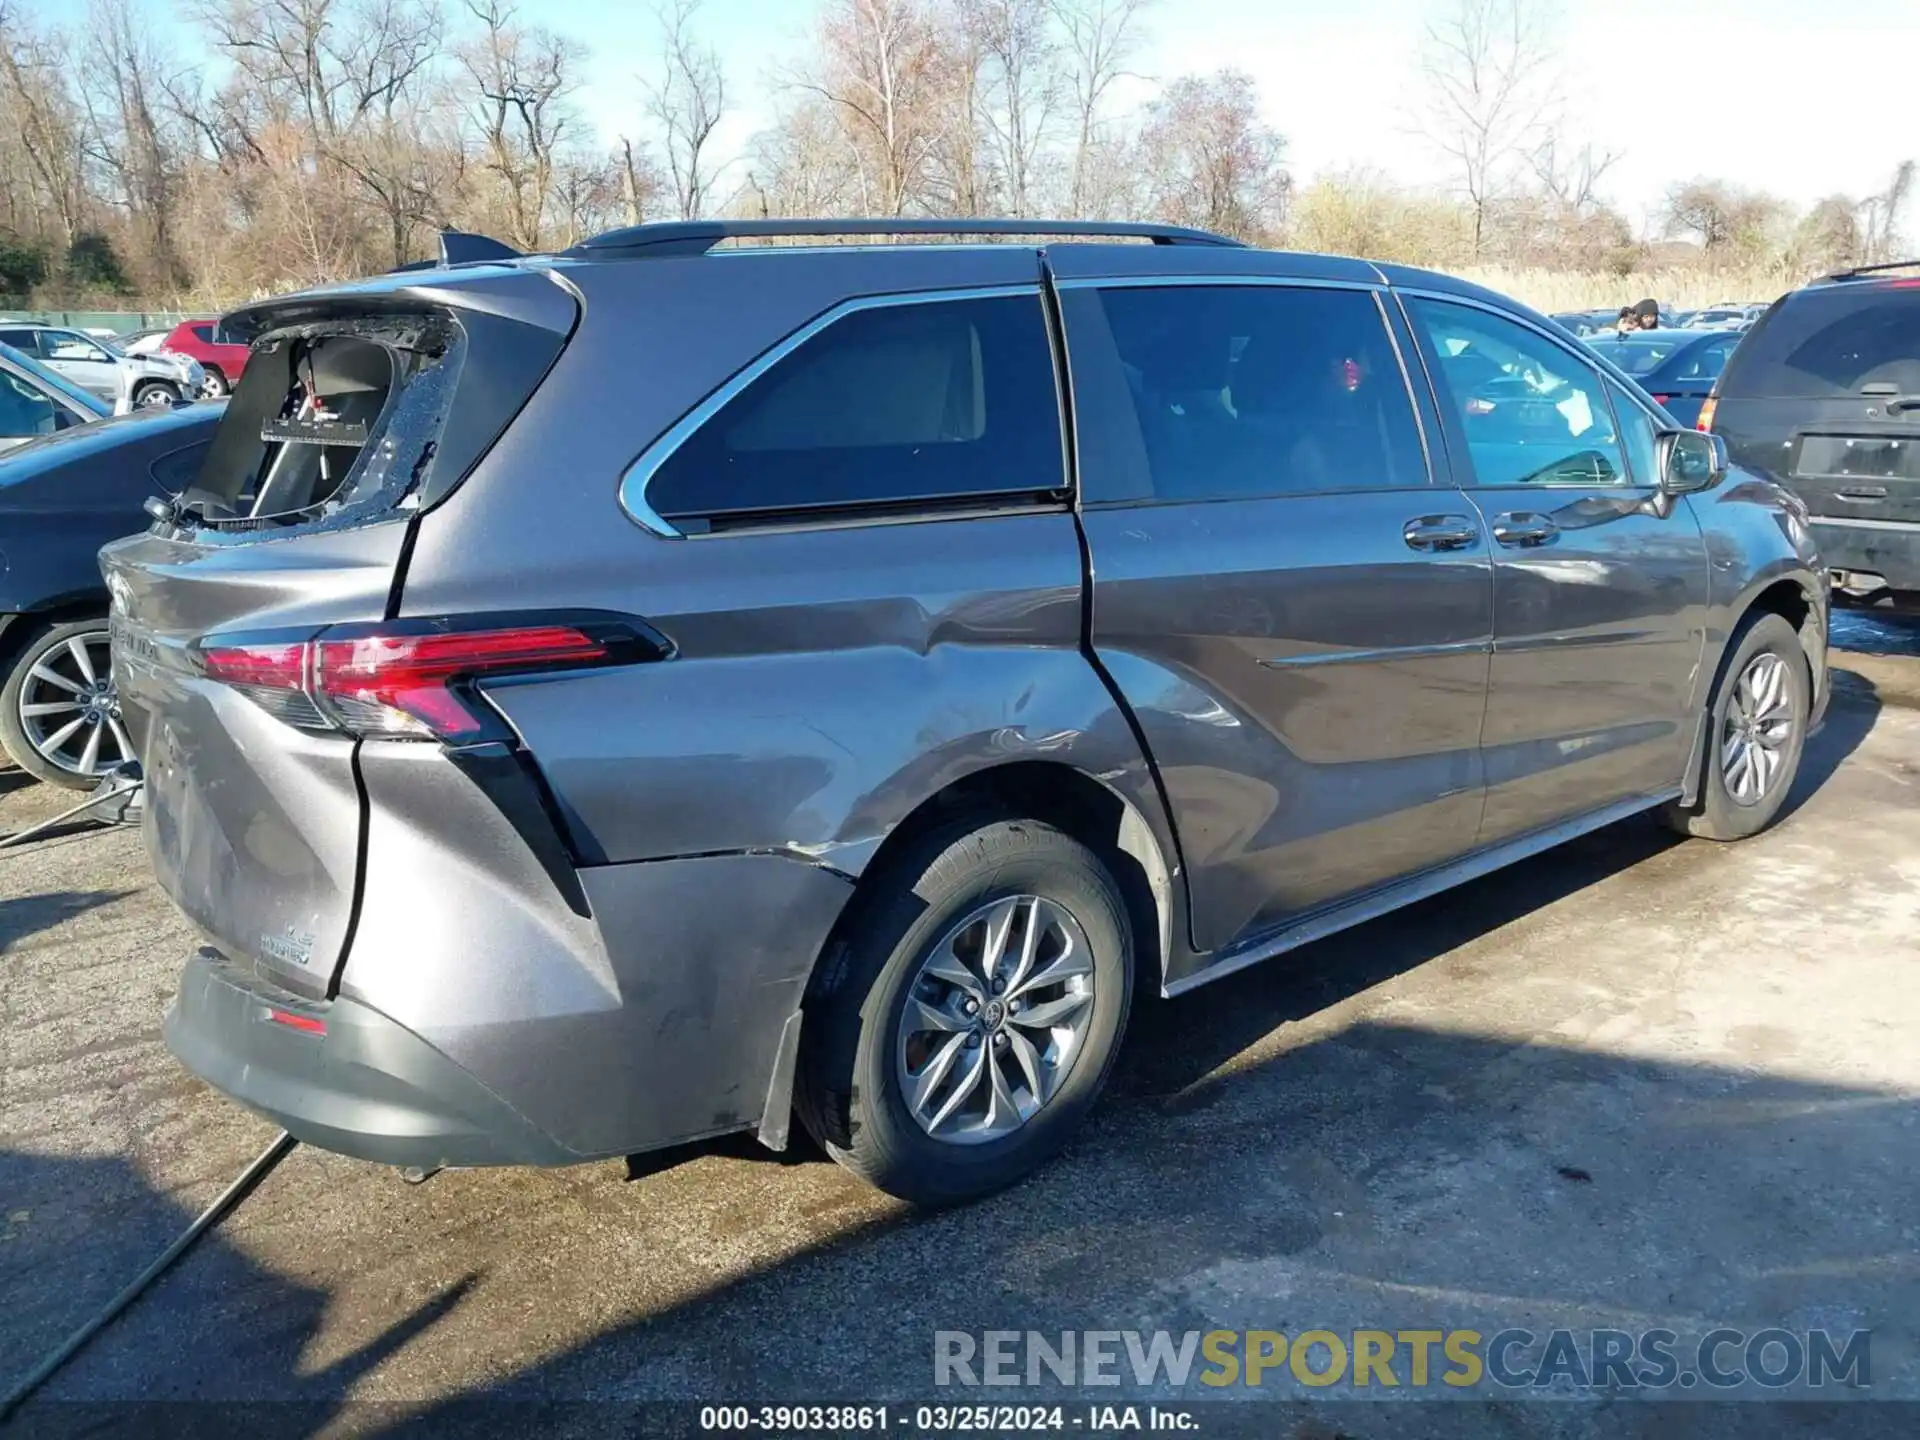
[102,221,1828,1202]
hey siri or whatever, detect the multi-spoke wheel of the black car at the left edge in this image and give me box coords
[0,620,134,789]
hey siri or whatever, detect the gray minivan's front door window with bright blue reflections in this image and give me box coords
[1407,300,1632,486]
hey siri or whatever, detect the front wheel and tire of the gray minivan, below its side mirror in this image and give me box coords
[1663,612,1812,841]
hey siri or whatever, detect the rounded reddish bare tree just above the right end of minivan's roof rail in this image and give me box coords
[1140,69,1292,240]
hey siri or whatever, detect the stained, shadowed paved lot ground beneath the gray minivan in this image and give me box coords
[0,660,1920,1436]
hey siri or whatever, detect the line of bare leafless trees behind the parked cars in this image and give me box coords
[0,0,1912,305]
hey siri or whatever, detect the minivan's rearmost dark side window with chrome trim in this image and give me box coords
[647,296,1066,528]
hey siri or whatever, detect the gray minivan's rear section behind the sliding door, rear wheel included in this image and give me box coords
[116,227,1177,1200]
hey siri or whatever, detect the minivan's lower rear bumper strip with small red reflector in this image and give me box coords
[165,950,586,1169]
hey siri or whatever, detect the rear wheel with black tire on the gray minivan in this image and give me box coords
[795,816,1133,1206]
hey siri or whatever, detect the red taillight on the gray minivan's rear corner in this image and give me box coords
[194,616,666,745]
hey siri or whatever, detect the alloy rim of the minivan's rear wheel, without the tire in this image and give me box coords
[897,895,1094,1144]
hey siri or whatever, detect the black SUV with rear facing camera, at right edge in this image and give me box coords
[1701,261,1920,603]
